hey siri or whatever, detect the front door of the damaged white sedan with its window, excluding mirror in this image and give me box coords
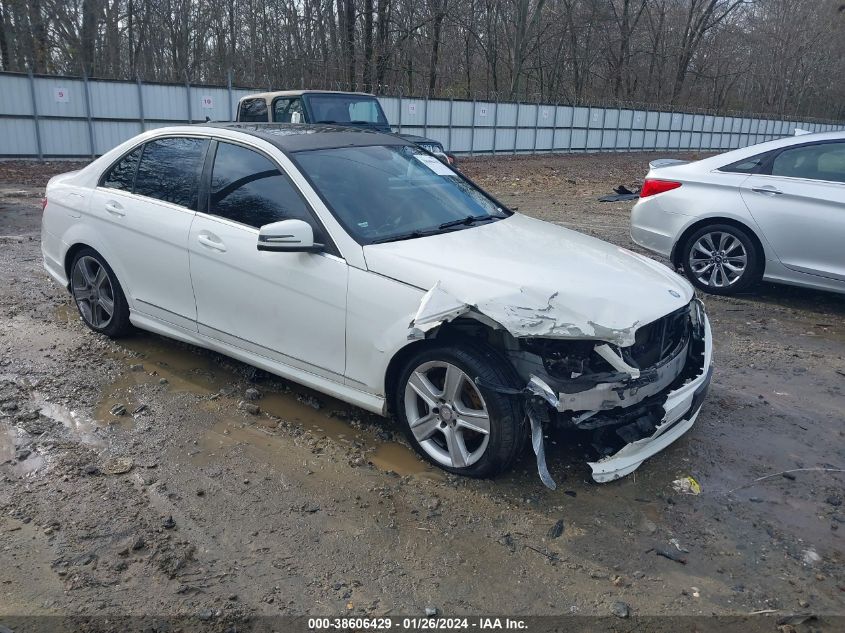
[188,141,348,382]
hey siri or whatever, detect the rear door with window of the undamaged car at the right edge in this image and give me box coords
[740,141,845,280]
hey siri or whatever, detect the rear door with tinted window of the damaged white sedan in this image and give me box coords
[89,137,210,331]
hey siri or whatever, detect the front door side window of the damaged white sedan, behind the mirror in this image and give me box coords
[209,142,325,243]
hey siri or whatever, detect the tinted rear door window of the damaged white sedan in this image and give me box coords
[135,138,208,209]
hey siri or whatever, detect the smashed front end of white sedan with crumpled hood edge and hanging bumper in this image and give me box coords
[408,282,713,489]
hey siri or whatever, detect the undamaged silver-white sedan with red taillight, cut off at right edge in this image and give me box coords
[631,132,845,295]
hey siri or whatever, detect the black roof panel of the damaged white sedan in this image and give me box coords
[203,122,413,153]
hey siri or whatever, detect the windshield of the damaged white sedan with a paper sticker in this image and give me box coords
[293,145,510,244]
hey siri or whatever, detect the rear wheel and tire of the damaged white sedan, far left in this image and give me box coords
[70,247,132,338]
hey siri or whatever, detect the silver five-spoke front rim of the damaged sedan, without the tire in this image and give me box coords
[405,361,490,468]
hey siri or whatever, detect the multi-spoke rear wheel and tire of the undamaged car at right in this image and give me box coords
[681,224,763,295]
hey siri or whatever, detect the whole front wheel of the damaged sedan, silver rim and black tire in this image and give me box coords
[393,343,528,477]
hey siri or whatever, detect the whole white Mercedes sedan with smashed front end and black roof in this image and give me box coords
[42,124,712,486]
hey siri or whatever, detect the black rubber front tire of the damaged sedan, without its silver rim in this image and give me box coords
[393,343,527,477]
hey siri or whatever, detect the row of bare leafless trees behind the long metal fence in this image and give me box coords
[0,0,845,117]
